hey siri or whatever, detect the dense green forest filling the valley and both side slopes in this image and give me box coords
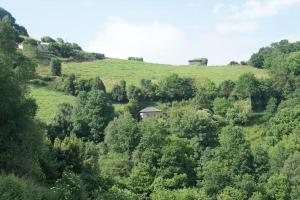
[0,7,300,200]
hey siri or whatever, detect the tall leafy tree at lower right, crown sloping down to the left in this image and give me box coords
[200,126,254,195]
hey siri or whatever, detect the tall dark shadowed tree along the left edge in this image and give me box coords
[0,29,43,179]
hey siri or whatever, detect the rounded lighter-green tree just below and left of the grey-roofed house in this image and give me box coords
[104,113,140,153]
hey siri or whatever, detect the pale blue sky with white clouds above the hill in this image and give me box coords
[0,0,300,65]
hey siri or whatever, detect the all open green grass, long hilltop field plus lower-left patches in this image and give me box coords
[31,58,268,122]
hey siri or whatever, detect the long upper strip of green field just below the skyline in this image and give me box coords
[63,58,267,89]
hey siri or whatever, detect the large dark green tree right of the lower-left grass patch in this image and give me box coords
[72,90,114,142]
